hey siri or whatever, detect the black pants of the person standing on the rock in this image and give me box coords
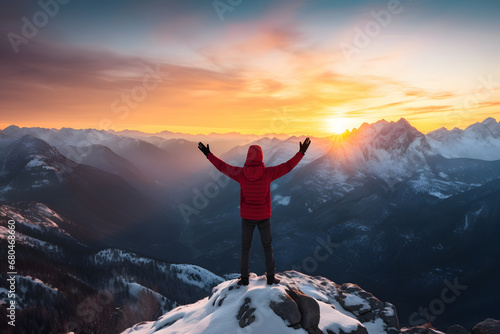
[240,218,275,278]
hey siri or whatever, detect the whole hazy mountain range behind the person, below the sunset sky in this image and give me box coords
[0,118,500,327]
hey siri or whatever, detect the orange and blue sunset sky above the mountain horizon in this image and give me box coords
[0,0,500,136]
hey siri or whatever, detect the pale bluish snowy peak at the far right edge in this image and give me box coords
[426,117,500,161]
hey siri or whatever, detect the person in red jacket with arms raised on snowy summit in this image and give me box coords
[198,137,311,285]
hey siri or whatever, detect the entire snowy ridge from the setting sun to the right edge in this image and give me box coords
[295,118,500,203]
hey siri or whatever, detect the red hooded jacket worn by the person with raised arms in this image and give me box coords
[207,145,304,220]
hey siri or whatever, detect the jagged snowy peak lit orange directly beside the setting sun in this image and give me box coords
[303,118,433,200]
